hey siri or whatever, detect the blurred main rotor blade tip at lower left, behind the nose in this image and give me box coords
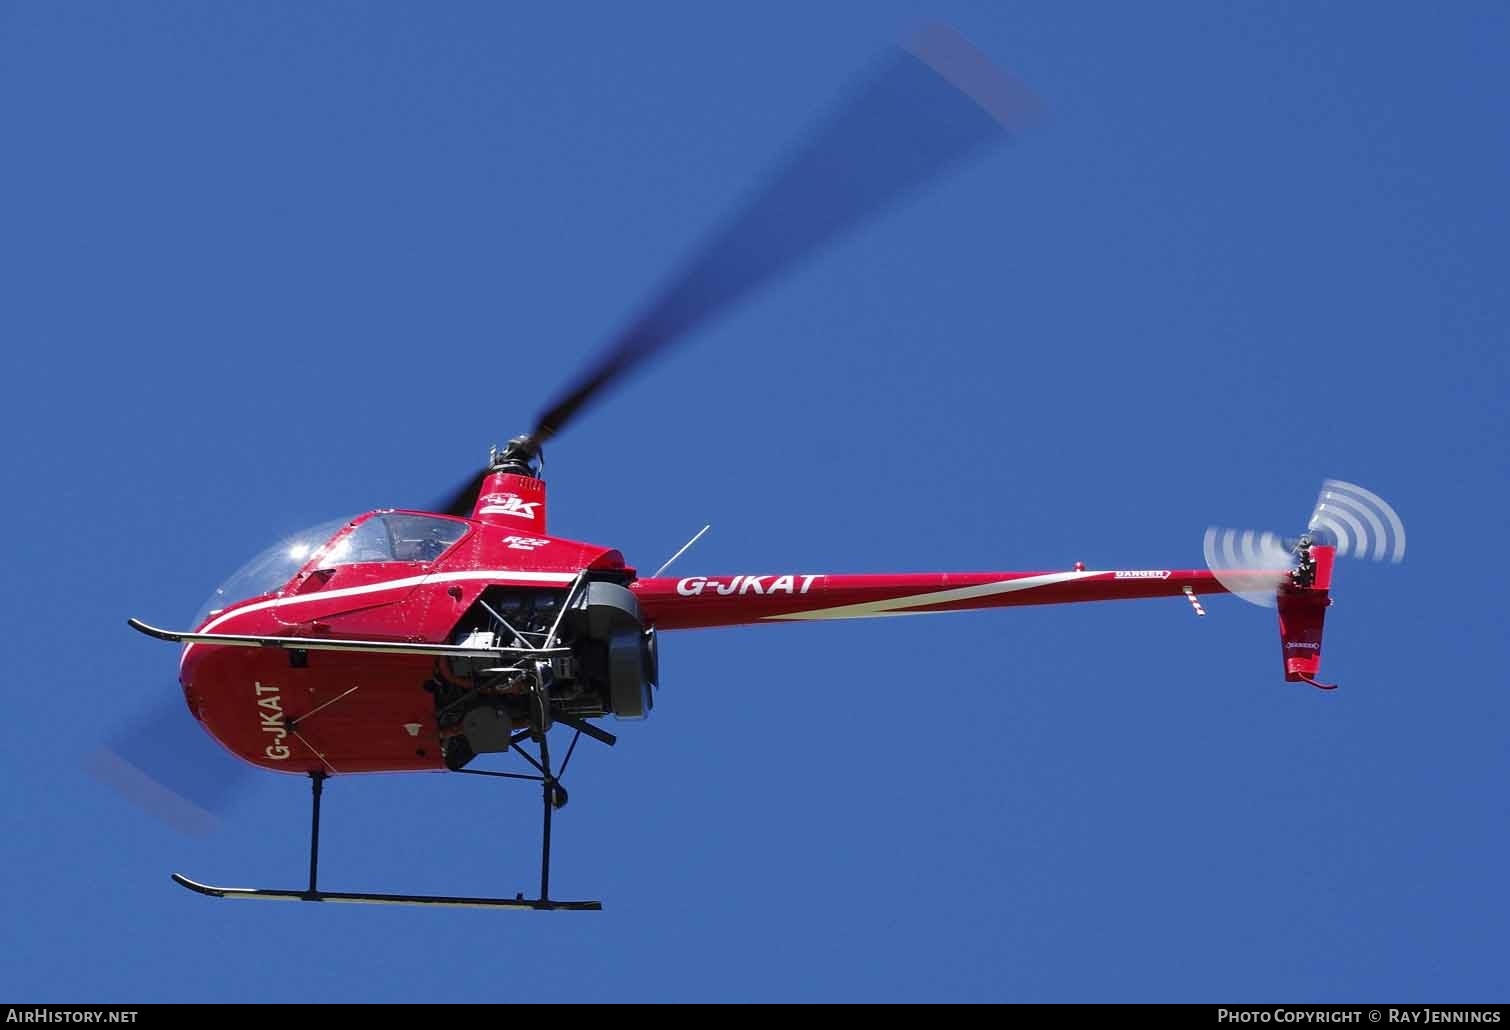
[85,690,254,837]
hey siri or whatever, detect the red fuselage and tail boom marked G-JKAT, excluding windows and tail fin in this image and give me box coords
[180,473,1250,773]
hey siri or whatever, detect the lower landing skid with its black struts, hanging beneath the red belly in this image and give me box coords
[174,712,600,912]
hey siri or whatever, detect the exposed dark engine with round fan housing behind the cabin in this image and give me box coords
[427,578,660,769]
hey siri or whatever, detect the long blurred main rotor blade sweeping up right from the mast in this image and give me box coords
[532,26,1040,444]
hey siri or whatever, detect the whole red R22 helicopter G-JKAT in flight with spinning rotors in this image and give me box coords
[101,27,1404,909]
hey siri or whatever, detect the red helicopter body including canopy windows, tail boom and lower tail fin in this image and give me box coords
[180,462,1332,773]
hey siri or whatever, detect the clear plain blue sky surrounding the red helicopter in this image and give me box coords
[0,2,1510,1003]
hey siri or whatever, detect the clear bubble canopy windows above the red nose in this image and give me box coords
[195,510,467,627]
